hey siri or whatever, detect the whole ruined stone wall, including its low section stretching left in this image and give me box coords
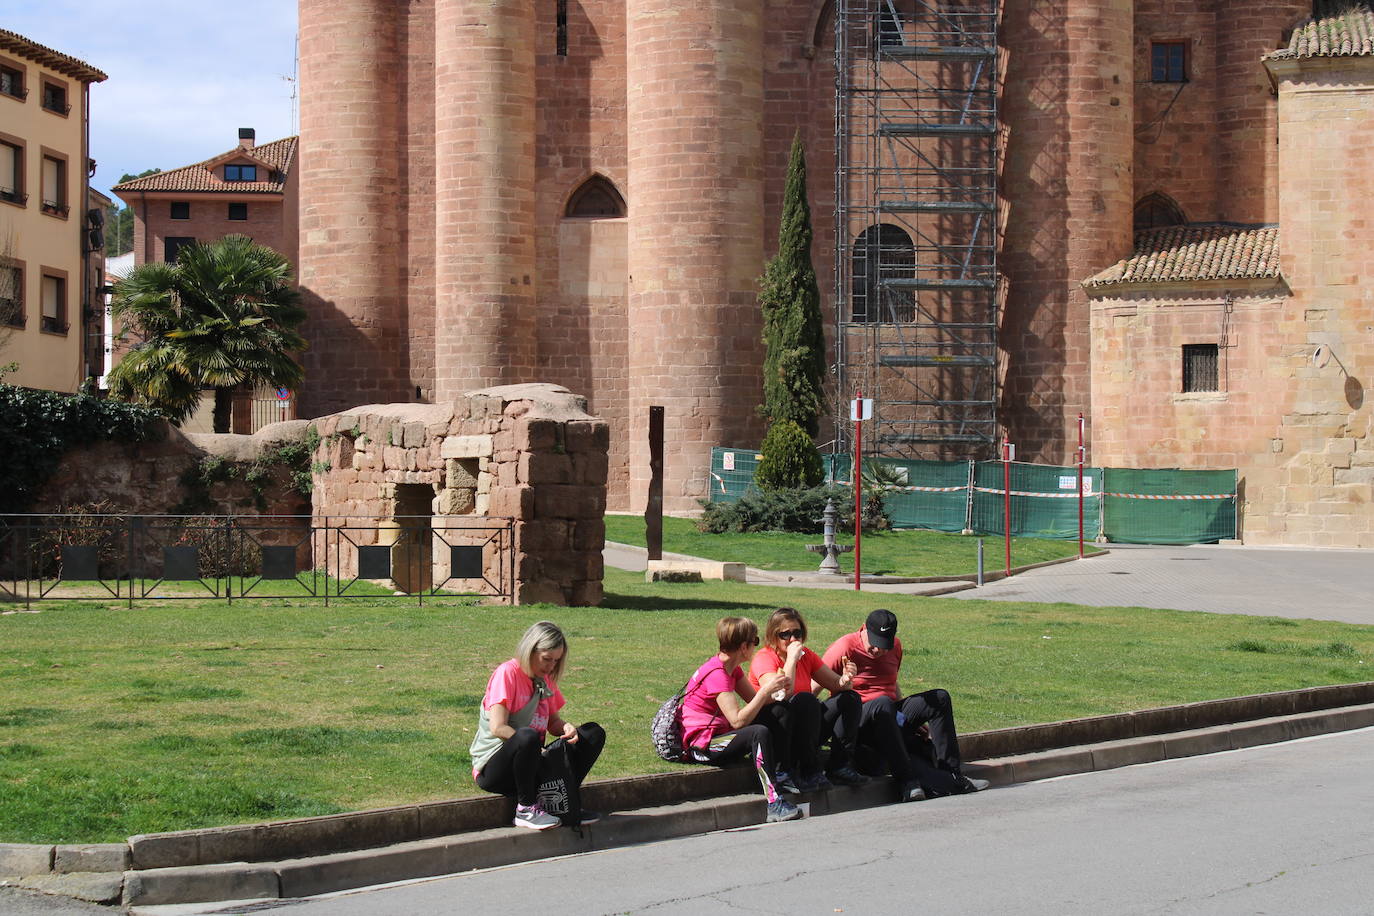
[30,385,610,606]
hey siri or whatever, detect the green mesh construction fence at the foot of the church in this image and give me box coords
[710,448,1237,544]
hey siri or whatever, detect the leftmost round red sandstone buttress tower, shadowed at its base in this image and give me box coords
[298,0,409,416]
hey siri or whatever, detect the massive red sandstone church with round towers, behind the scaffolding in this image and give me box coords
[298,0,1374,545]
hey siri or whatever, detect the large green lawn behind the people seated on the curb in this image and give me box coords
[0,570,1374,842]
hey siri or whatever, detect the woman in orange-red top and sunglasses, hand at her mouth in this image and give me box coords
[749,607,868,792]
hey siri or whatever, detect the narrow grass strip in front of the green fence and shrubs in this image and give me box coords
[606,515,1094,575]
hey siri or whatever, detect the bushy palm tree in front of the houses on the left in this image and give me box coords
[107,235,306,433]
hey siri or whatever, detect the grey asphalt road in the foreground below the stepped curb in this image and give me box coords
[193,729,1374,916]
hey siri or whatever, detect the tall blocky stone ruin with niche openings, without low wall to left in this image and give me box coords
[312,385,610,606]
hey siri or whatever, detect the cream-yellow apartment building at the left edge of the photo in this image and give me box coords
[0,29,106,391]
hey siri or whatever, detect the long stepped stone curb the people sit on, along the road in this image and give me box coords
[10,681,1374,906]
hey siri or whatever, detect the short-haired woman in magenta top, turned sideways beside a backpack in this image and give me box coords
[682,617,801,821]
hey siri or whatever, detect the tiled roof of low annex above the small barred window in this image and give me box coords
[1083,222,1279,288]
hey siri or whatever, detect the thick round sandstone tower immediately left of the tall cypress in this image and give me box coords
[627,0,764,511]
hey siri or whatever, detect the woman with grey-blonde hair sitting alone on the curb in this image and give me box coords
[470,621,606,829]
